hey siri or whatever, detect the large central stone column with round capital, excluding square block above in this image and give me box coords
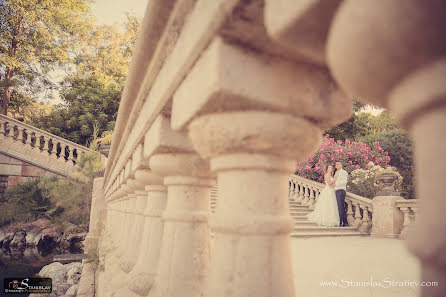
[189,111,320,297]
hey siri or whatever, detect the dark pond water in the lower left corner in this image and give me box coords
[0,244,82,297]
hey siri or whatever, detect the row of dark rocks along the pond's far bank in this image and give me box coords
[0,219,87,250]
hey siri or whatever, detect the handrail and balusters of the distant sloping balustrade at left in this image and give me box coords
[0,115,89,170]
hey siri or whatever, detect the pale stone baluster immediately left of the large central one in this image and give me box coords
[149,153,215,297]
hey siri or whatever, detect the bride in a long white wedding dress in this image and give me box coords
[307,165,339,227]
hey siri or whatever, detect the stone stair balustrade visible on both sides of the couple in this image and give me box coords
[289,174,373,233]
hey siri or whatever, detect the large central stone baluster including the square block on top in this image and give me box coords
[166,34,351,297]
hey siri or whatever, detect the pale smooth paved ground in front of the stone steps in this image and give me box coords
[291,237,419,297]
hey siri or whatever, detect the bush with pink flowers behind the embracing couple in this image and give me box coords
[296,134,390,182]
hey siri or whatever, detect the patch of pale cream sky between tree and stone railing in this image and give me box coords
[92,0,149,25]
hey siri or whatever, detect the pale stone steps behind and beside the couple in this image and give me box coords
[289,199,363,237]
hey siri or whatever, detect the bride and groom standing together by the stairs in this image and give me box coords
[307,162,348,227]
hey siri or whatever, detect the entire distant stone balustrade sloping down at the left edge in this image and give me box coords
[0,115,88,176]
